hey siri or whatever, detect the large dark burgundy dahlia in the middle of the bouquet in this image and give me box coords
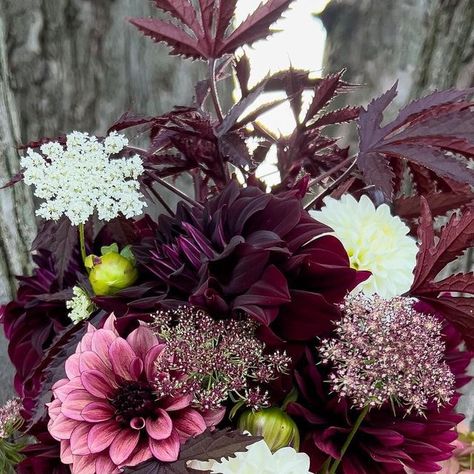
[136,182,367,341]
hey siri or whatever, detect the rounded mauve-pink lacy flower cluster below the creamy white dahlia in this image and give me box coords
[320,295,454,414]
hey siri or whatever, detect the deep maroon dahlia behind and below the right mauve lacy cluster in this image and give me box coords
[288,307,472,474]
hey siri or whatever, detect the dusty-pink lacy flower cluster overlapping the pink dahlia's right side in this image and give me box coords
[153,306,290,410]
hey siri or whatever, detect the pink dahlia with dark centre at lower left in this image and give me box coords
[48,315,222,474]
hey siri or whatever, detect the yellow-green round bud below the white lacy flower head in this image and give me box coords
[86,244,138,296]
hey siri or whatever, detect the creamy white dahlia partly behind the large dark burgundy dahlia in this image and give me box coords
[310,195,418,298]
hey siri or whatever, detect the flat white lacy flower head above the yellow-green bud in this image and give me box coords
[21,132,146,225]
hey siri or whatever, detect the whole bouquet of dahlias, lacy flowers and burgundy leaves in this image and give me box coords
[0,0,474,474]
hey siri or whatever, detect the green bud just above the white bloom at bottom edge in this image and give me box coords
[237,407,300,452]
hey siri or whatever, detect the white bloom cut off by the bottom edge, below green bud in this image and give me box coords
[189,440,311,474]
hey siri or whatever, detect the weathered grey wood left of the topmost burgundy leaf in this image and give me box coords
[0,0,203,402]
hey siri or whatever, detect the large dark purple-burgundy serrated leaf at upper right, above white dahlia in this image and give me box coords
[357,83,474,200]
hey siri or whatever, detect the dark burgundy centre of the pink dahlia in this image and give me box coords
[110,381,156,424]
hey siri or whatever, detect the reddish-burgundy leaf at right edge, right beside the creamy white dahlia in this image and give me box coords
[409,198,474,350]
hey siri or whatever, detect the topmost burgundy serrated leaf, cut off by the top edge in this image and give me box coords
[130,0,293,60]
